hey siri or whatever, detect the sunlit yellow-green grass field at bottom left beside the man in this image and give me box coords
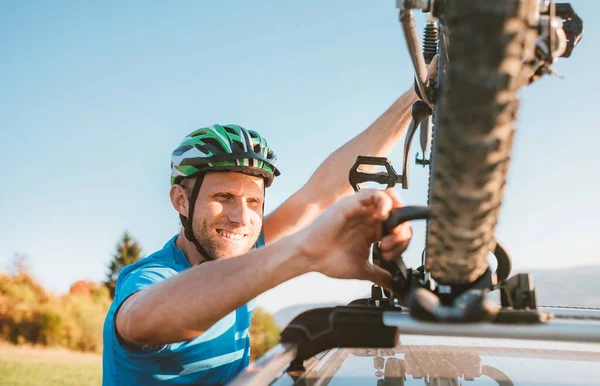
[0,342,102,386]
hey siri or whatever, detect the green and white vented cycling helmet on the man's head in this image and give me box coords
[171,125,280,186]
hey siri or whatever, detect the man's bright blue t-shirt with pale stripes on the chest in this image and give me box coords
[102,233,264,386]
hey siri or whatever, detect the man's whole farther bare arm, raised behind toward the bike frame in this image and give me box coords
[264,87,417,243]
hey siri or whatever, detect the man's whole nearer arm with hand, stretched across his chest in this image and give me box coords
[116,190,406,347]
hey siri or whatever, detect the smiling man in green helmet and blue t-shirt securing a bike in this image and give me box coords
[103,61,435,385]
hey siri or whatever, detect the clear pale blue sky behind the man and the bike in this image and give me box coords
[0,0,600,311]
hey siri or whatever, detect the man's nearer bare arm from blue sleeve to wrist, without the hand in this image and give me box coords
[117,237,310,346]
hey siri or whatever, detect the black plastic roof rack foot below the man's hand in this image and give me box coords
[281,306,399,373]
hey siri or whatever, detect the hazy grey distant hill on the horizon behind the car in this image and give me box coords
[274,265,600,328]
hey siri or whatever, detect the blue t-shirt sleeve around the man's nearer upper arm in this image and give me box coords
[114,265,177,356]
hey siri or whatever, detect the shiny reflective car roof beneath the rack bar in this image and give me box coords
[273,335,600,386]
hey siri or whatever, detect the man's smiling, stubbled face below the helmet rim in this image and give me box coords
[193,172,264,259]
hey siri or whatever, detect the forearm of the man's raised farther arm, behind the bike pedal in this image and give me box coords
[304,87,417,208]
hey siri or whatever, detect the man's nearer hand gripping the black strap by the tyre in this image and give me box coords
[298,189,412,289]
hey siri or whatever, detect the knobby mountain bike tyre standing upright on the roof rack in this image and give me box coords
[425,0,537,284]
